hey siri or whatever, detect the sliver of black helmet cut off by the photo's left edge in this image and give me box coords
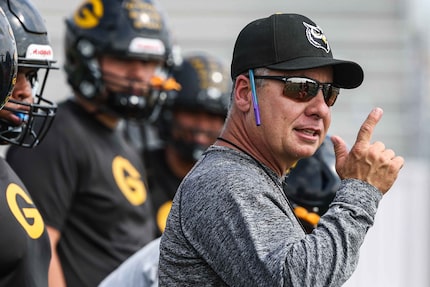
[0,8,18,111]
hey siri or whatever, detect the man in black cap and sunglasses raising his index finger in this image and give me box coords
[159,14,403,286]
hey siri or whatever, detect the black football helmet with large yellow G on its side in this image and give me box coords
[64,0,176,119]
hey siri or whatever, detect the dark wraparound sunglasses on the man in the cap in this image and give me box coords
[254,75,340,107]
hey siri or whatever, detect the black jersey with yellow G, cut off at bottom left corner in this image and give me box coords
[0,158,51,287]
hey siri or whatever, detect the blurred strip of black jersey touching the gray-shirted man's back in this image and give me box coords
[145,148,182,235]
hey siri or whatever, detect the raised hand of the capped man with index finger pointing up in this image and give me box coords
[331,108,404,194]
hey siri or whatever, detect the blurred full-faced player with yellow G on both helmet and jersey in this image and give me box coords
[7,0,177,287]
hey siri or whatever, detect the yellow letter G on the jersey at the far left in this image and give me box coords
[6,183,45,239]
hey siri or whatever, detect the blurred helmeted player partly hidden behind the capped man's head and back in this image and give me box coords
[99,53,230,287]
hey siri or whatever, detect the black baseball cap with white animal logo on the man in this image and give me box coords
[231,14,363,89]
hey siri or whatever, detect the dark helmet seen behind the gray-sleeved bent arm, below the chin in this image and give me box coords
[283,136,340,232]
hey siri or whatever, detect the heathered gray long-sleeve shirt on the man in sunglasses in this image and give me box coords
[159,146,382,287]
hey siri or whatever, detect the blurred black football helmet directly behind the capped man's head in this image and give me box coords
[158,53,231,161]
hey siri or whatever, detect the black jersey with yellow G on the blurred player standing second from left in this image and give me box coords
[7,100,156,286]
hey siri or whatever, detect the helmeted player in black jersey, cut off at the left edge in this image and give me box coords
[0,0,56,287]
